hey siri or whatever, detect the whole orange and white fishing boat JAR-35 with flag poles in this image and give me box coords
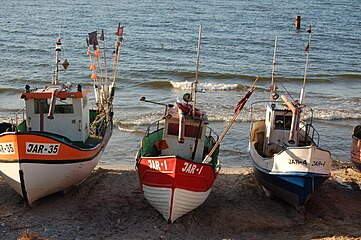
[0,25,123,204]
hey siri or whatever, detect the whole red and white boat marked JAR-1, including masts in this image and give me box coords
[136,25,253,223]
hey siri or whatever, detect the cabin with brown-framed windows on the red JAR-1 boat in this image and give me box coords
[162,107,208,162]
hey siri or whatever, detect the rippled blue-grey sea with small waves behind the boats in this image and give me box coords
[0,0,361,168]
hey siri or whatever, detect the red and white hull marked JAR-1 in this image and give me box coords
[138,156,218,222]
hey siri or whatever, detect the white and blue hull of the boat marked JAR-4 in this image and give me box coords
[249,131,332,209]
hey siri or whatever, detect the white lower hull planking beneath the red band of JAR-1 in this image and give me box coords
[143,184,212,223]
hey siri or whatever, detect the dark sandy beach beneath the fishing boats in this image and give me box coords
[0,163,361,240]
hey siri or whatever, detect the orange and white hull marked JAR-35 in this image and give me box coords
[0,125,111,204]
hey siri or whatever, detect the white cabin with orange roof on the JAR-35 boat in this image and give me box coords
[21,85,90,143]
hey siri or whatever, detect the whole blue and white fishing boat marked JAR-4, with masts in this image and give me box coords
[249,27,332,210]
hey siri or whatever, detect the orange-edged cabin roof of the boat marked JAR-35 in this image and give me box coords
[21,85,91,99]
